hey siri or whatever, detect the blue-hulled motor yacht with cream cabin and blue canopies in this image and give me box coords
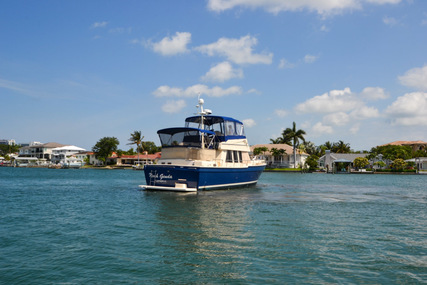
[140,97,266,192]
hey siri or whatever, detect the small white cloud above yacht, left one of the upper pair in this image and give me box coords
[149,32,191,56]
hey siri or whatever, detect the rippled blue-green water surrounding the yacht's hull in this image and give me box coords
[0,168,427,284]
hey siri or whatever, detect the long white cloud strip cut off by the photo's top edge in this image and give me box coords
[208,0,401,16]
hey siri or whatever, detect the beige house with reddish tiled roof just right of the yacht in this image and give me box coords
[251,144,309,168]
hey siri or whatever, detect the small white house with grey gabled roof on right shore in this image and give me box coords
[319,150,368,173]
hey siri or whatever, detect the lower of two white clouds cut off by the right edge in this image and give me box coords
[385,92,427,126]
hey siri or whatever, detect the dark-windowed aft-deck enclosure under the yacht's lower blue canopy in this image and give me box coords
[157,128,215,148]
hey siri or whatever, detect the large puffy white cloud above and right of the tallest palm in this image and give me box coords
[295,87,363,113]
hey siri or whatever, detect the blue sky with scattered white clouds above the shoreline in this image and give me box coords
[0,0,427,150]
